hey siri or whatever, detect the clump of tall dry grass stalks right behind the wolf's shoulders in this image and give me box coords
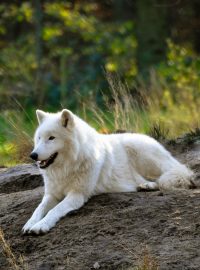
[83,73,148,133]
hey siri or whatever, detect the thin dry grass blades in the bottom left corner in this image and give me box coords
[0,228,28,270]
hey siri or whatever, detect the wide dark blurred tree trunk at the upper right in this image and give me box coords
[136,0,169,76]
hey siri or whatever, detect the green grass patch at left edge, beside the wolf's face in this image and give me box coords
[0,109,36,166]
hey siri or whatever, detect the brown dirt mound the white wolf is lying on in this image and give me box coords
[0,144,200,270]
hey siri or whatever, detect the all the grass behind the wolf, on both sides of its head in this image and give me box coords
[0,72,200,166]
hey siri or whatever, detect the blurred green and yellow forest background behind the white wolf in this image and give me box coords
[0,0,200,164]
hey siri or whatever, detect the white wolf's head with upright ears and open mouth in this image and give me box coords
[30,109,75,169]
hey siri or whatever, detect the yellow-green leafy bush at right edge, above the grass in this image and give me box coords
[158,40,200,99]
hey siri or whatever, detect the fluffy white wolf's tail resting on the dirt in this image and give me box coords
[158,164,195,190]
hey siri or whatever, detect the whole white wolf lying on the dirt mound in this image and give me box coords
[23,109,193,234]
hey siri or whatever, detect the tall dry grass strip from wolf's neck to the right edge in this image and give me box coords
[84,70,200,139]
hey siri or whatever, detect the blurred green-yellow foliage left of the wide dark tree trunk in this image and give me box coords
[0,1,137,108]
